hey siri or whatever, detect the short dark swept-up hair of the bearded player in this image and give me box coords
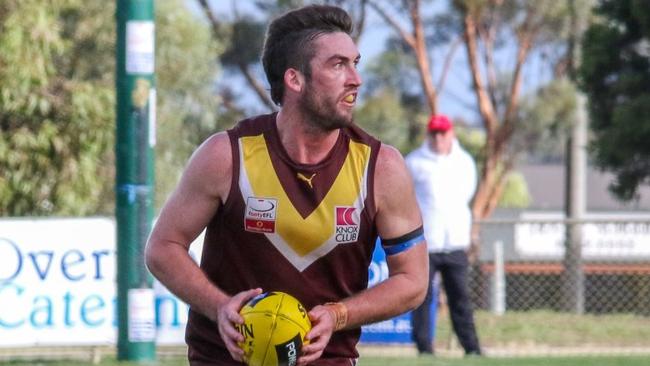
[262,5,352,105]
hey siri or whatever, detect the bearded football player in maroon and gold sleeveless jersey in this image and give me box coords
[146,5,428,366]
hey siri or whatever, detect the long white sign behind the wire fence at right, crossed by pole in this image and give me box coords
[515,212,650,260]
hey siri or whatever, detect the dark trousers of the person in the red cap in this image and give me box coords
[411,250,481,354]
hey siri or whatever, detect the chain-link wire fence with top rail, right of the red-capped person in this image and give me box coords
[470,215,650,315]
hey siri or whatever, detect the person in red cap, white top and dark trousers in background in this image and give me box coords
[406,115,481,354]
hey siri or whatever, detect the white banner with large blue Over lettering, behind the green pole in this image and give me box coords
[0,218,200,347]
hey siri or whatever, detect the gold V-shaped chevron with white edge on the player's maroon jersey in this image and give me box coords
[239,134,370,271]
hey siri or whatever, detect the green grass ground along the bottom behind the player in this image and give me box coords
[0,311,650,366]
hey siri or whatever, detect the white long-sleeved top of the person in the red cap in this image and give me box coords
[406,139,476,252]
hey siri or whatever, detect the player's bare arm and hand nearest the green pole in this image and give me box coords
[145,133,261,361]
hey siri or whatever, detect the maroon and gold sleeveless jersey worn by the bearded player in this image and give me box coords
[186,114,380,365]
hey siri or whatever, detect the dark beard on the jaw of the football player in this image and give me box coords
[299,84,353,132]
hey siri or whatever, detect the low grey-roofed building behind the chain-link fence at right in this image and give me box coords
[478,164,650,315]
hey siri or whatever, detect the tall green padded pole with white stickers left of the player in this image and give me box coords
[115,0,156,361]
